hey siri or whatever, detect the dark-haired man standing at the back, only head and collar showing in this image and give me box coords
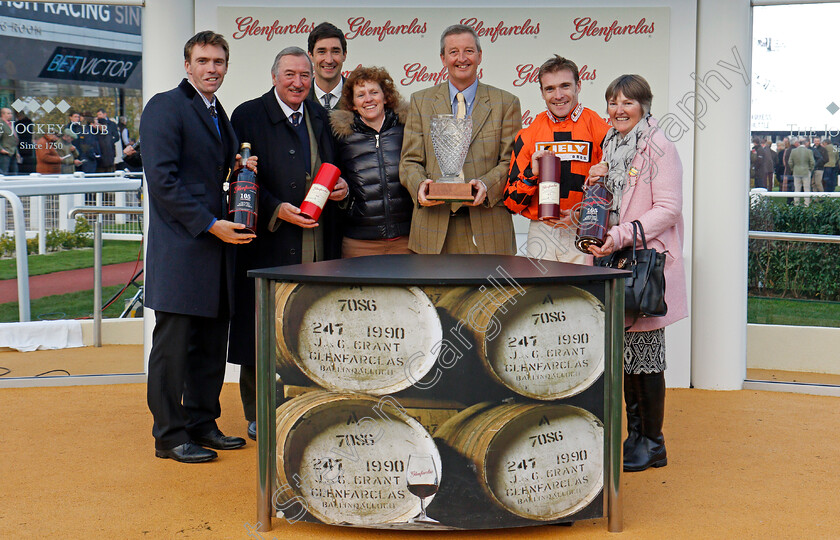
[307,22,347,111]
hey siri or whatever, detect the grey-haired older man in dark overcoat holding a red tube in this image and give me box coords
[228,47,347,438]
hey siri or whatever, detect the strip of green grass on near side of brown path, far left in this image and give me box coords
[0,285,137,322]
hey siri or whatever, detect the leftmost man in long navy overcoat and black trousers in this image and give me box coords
[140,31,256,463]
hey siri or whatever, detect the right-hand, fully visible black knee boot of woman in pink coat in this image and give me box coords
[624,372,668,472]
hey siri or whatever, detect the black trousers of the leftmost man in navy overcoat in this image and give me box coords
[146,310,230,450]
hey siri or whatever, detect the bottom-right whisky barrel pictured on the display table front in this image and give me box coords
[435,402,604,521]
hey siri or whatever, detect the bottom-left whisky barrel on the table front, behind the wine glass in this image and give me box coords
[275,391,441,525]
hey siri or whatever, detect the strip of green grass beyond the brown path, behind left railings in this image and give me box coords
[0,240,140,280]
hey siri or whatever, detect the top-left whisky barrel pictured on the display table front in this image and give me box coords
[276,284,443,395]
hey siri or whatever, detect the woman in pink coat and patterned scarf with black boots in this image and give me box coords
[588,75,688,472]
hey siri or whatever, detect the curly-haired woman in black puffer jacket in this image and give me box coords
[330,66,413,257]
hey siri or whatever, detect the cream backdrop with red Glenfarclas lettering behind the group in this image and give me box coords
[217,7,669,130]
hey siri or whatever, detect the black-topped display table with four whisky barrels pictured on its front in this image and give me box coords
[248,255,628,532]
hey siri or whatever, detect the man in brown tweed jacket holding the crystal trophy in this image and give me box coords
[400,25,522,255]
